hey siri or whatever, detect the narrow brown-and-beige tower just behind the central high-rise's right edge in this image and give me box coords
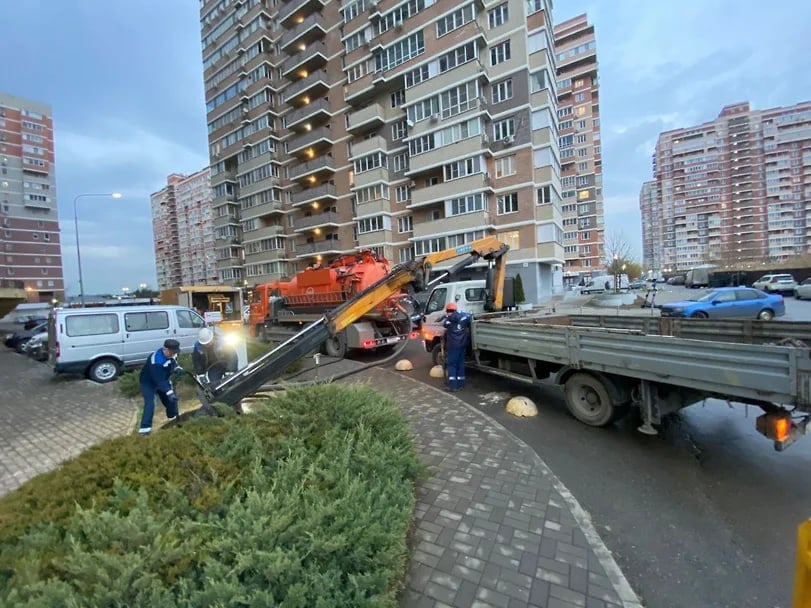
[555,14,605,284]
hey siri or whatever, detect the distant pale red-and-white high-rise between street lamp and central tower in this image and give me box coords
[151,169,218,290]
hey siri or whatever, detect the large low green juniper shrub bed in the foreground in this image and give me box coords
[0,385,421,607]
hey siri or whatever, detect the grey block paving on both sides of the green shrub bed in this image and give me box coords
[0,348,641,608]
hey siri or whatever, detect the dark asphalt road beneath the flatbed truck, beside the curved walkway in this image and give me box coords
[394,306,811,608]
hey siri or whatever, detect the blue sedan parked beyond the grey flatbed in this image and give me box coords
[660,287,786,321]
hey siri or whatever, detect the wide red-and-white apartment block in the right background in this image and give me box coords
[641,102,811,270]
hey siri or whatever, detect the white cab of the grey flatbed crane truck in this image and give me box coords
[421,280,487,364]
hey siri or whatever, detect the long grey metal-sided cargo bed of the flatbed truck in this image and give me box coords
[472,315,811,411]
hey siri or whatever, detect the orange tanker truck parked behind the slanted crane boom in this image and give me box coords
[249,250,414,357]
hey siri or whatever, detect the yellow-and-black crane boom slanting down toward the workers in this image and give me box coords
[200,237,509,406]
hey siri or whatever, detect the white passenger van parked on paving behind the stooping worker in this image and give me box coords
[48,305,206,382]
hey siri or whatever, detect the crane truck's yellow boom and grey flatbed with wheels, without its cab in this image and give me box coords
[201,237,811,450]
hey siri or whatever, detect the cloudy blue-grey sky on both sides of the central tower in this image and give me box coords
[0,0,811,293]
